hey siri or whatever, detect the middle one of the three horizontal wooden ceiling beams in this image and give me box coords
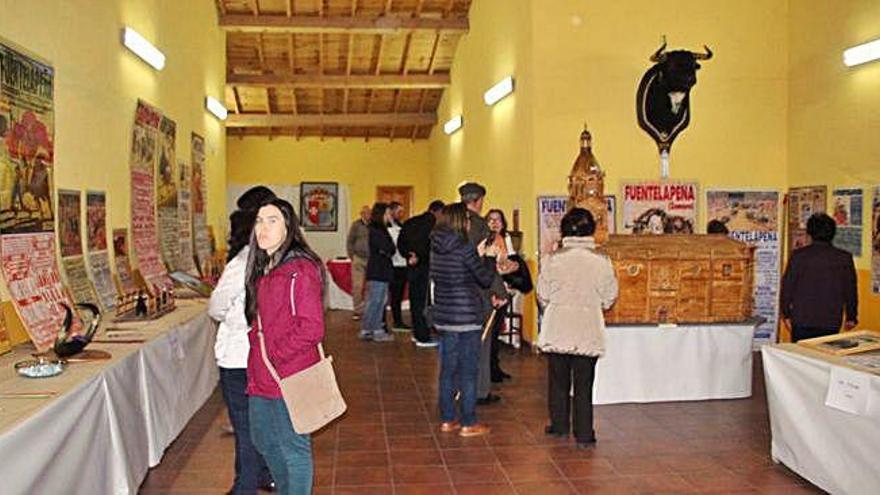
[226,74,451,89]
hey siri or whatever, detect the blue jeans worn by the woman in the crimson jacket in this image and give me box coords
[249,396,314,495]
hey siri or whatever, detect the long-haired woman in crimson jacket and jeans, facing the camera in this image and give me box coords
[245,199,324,495]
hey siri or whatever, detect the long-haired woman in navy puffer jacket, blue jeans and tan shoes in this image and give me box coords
[430,203,495,437]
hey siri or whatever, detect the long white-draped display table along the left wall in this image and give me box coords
[0,300,217,494]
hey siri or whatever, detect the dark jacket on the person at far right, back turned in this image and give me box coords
[781,241,859,328]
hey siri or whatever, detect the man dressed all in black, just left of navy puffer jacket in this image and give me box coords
[397,200,443,348]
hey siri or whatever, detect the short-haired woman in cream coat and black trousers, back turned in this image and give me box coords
[538,208,617,448]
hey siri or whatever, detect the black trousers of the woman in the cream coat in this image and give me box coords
[547,353,598,442]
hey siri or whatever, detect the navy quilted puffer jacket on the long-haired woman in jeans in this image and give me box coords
[430,229,495,328]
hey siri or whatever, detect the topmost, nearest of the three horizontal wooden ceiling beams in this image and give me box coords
[220,14,469,34]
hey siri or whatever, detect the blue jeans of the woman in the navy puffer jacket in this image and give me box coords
[440,330,482,426]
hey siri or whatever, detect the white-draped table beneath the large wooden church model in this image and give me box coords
[593,322,757,404]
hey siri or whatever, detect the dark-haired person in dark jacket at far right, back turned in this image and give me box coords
[781,213,859,342]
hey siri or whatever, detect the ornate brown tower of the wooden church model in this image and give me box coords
[568,125,614,244]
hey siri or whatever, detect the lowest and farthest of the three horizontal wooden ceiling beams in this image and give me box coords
[226,112,437,128]
